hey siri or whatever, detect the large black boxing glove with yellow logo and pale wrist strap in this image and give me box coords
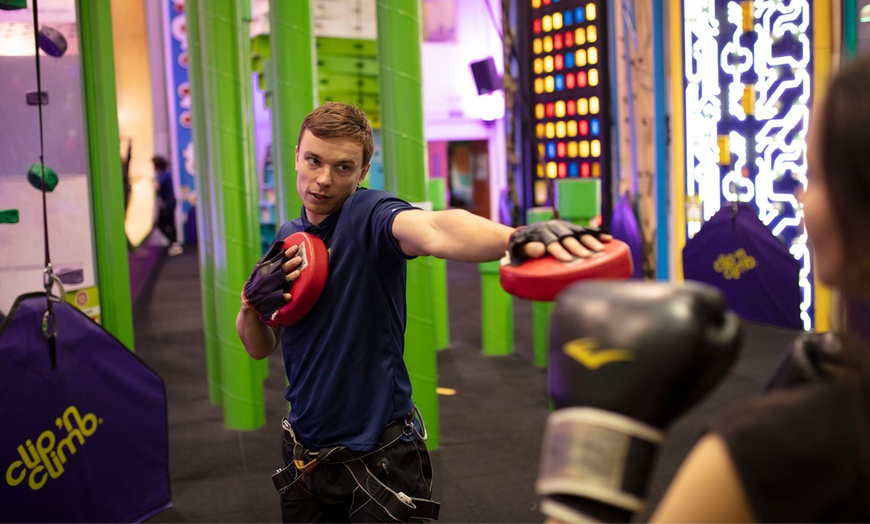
[537,281,741,522]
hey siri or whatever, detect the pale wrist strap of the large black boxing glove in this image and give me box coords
[537,407,663,518]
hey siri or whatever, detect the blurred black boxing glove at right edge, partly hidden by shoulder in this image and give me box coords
[764,332,867,391]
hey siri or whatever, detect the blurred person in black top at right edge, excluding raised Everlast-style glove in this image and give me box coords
[654,51,870,522]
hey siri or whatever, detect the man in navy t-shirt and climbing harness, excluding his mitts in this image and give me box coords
[236,102,608,522]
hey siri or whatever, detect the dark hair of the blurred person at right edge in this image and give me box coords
[819,54,870,282]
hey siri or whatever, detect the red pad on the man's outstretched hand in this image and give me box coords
[499,239,634,301]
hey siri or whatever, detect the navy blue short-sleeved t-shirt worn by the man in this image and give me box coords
[276,189,415,451]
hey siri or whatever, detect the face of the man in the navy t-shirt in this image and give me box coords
[296,130,369,225]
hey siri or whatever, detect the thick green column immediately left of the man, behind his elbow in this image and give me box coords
[196,0,268,429]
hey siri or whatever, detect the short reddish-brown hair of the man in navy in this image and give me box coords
[297,102,375,167]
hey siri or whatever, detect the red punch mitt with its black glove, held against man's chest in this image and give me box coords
[244,233,329,327]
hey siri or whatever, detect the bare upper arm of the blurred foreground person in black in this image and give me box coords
[650,433,758,522]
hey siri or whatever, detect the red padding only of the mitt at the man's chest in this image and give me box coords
[266,233,329,327]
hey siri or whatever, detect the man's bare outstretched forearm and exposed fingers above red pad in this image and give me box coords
[393,209,609,262]
